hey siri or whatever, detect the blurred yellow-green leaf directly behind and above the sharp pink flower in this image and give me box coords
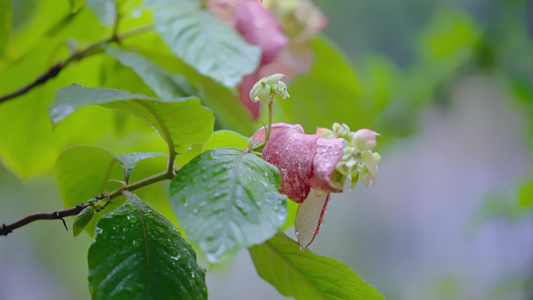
[279,38,372,132]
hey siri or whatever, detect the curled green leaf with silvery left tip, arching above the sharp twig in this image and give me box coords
[50,84,214,152]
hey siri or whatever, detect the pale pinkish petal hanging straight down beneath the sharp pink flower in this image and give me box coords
[294,189,329,250]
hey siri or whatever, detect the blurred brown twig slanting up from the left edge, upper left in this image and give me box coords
[0,25,154,104]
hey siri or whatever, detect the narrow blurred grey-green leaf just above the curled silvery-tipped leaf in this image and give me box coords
[106,46,198,99]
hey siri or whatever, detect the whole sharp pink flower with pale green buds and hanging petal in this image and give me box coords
[252,123,379,250]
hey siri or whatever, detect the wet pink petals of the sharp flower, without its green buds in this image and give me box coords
[252,123,344,249]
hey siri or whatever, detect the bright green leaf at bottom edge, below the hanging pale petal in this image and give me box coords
[249,232,384,300]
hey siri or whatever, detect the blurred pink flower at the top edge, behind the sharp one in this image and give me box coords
[209,0,327,120]
